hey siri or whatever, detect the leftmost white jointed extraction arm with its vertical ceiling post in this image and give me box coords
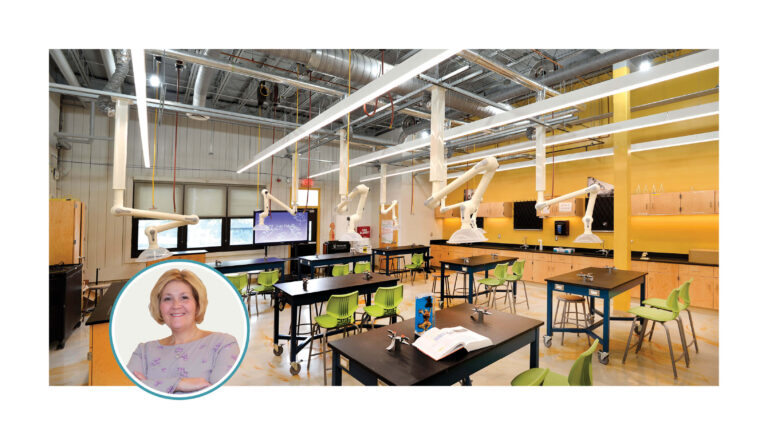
[111,98,200,261]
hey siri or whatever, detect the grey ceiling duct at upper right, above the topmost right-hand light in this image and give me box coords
[488,50,652,101]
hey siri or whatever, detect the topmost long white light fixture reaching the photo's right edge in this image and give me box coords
[328,50,720,176]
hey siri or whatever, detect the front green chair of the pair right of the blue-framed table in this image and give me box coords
[621,288,690,379]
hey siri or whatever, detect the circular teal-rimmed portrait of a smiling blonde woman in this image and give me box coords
[109,260,250,399]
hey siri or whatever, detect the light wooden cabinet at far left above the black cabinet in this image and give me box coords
[48,199,85,264]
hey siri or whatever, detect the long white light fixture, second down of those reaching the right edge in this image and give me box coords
[360,102,720,181]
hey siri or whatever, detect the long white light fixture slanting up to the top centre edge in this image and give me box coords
[237,50,459,174]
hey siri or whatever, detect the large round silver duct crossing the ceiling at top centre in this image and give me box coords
[259,50,495,118]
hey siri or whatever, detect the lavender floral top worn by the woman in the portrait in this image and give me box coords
[128,332,240,394]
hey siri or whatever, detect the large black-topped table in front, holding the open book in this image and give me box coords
[329,304,544,385]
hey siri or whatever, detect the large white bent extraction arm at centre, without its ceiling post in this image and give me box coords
[424,157,499,244]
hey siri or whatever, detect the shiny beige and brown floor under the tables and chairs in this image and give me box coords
[49,275,719,385]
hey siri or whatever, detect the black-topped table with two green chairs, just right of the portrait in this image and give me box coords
[272,273,397,375]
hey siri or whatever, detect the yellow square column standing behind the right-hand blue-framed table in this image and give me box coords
[611,62,632,311]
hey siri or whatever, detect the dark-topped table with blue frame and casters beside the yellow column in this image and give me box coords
[543,267,646,364]
